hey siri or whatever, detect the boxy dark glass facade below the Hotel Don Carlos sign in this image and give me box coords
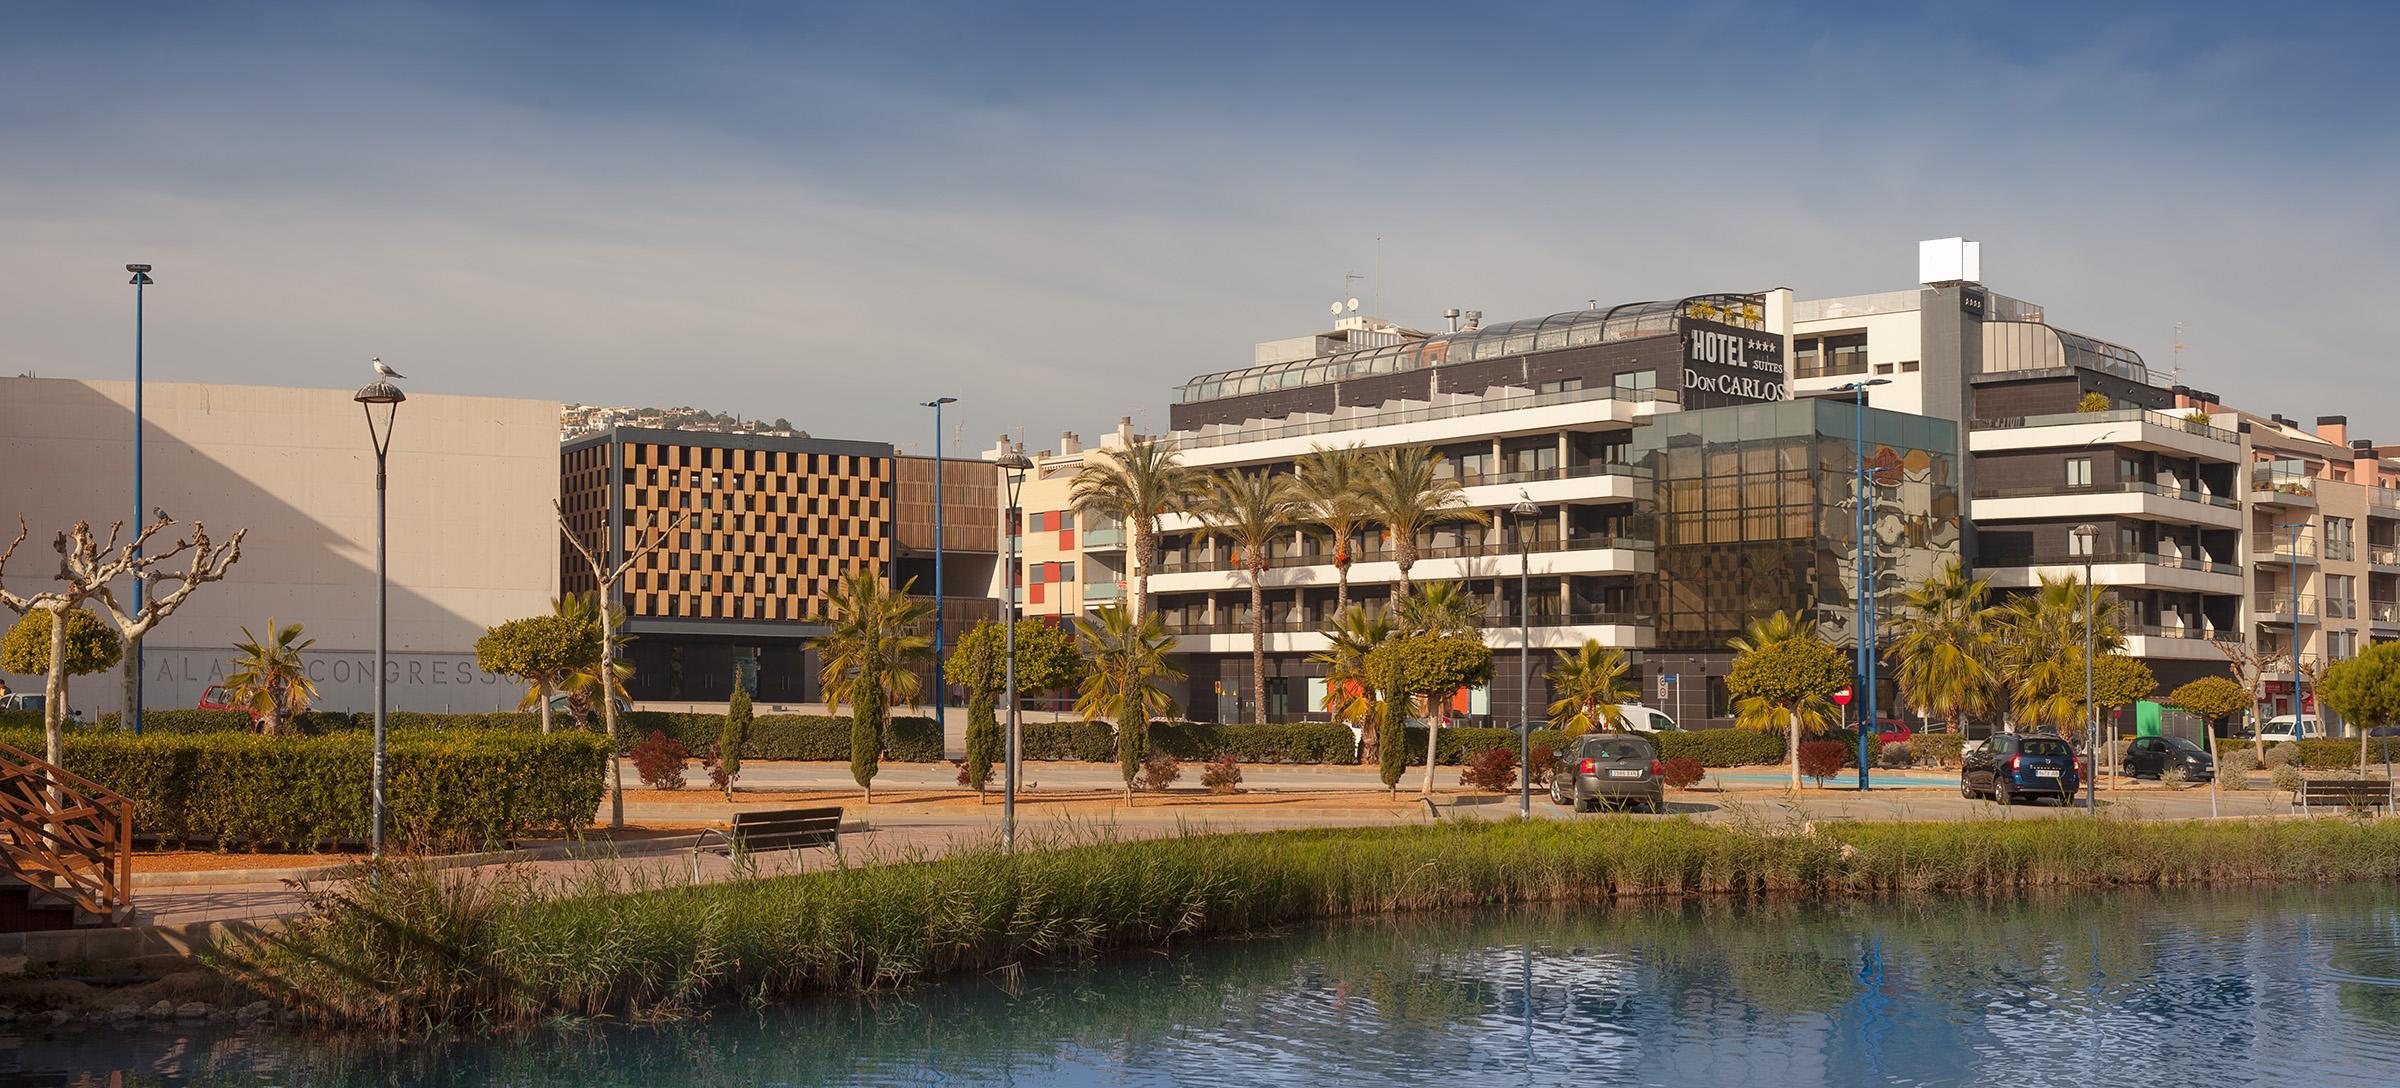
[1632,399,1961,653]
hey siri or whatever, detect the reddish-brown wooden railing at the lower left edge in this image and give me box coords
[0,745,134,922]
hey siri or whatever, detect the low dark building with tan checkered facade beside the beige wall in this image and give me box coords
[559,428,998,701]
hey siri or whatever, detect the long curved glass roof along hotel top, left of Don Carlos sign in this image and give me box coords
[1176,293,1766,403]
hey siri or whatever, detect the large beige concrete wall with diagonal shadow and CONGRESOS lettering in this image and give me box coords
[0,377,559,716]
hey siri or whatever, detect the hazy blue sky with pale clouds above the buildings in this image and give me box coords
[0,0,2400,454]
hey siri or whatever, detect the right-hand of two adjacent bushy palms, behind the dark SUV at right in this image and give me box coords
[1999,574,2124,735]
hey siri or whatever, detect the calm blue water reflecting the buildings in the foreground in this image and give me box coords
[14,886,2400,1088]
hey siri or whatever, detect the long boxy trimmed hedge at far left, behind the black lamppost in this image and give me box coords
[0,730,607,850]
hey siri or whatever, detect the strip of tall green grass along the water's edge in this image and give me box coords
[223,819,2400,1030]
